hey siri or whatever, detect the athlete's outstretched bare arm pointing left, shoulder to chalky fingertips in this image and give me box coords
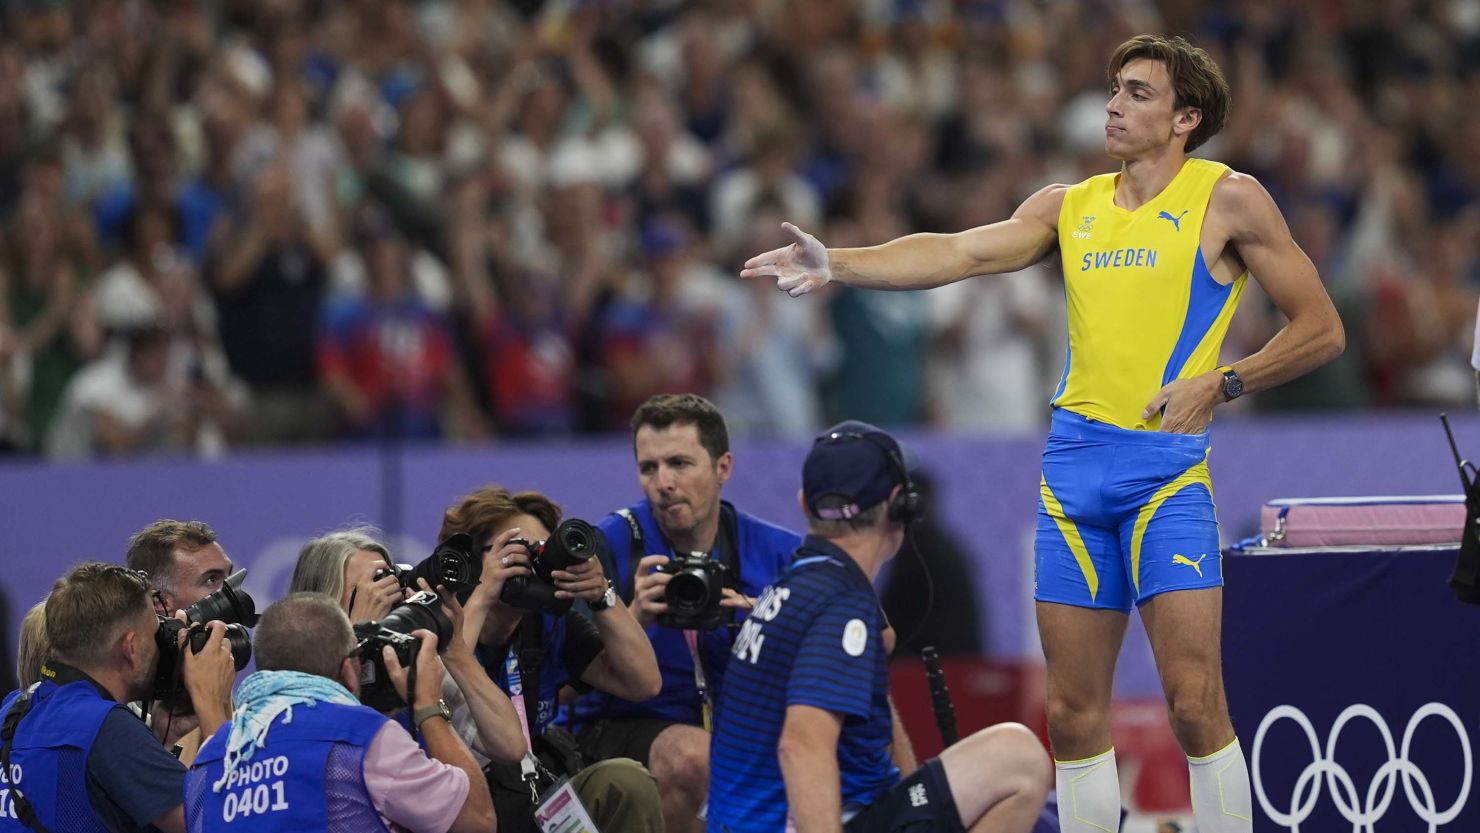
[740,185,1067,297]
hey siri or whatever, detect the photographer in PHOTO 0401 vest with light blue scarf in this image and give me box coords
[185,593,496,833]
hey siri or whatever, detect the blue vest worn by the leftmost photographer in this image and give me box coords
[0,681,124,833]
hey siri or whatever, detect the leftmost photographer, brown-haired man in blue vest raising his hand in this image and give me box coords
[0,562,235,833]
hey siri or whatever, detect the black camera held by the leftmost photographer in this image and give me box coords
[151,570,258,715]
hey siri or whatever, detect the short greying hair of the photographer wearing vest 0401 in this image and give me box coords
[252,592,355,681]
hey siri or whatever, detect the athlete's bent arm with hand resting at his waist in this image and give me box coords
[1141,173,1347,434]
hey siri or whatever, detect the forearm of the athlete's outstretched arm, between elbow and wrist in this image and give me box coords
[827,234,980,290]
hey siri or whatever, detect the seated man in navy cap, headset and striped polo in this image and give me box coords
[707,422,1054,833]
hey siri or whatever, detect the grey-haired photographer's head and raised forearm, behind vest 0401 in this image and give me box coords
[289,528,525,763]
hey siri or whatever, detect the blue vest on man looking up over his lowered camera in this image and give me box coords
[574,500,802,728]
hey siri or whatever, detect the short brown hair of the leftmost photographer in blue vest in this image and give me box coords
[43,561,154,664]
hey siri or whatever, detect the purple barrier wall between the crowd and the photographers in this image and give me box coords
[0,414,1480,695]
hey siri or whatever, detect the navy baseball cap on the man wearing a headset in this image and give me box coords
[802,420,909,521]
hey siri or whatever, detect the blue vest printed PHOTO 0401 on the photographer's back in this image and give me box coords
[185,703,386,833]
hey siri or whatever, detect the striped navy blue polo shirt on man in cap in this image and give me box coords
[707,536,900,833]
